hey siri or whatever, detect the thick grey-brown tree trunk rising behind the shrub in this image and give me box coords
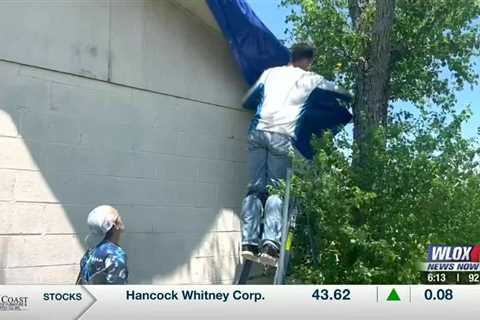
[350,0,395,169]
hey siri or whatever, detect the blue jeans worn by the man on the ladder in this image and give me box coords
[241,130,292,248]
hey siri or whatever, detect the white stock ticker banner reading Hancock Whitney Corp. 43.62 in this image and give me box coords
[0,285,480,320]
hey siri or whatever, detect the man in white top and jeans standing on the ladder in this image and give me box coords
[241,44,348,266]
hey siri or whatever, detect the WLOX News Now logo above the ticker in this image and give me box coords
[426,244,480,271]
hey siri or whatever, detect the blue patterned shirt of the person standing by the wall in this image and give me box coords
[80,240,128,284]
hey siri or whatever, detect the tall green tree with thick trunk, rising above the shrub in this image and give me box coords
[281,0,480,164]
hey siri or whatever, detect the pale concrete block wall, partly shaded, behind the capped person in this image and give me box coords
[0,0,251,284]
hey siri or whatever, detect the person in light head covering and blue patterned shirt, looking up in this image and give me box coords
[77,205,128,284]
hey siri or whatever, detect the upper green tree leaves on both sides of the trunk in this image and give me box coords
[282,0,480,103]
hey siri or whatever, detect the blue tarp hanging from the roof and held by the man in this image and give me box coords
[207,0,352,158]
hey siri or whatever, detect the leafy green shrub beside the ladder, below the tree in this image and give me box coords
[289,109,480,284]
